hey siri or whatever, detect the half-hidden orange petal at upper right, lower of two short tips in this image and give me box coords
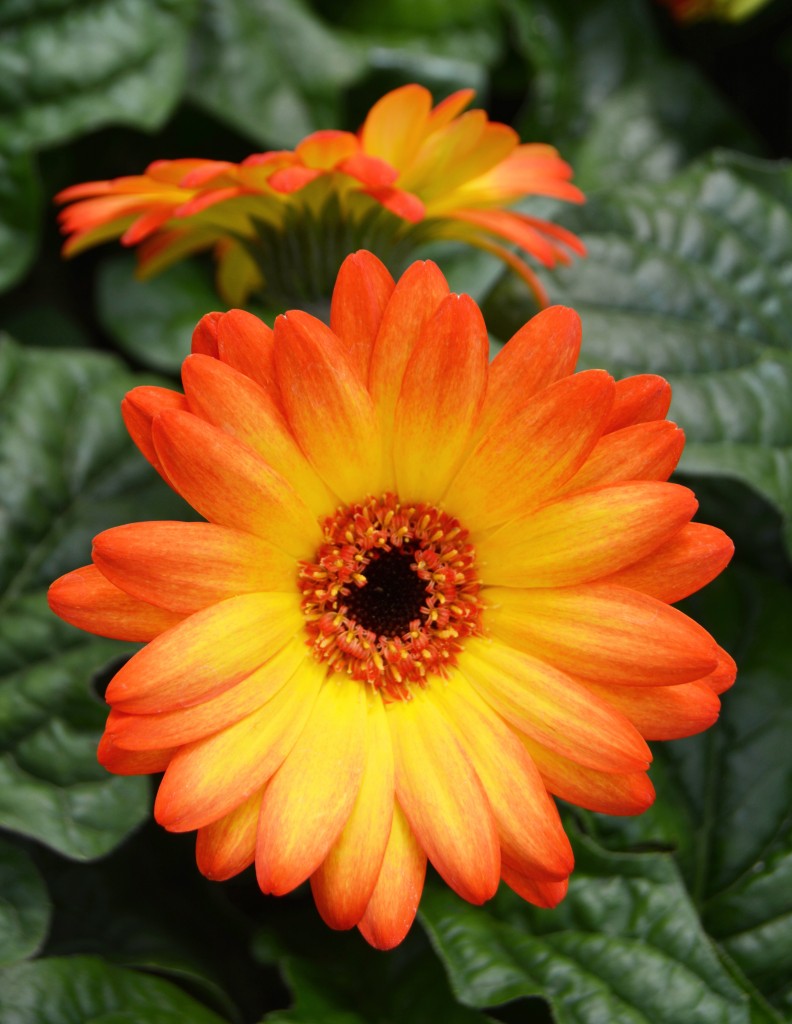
[562,420,684,494]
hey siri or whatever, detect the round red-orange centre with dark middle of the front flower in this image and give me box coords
[299,495,483,700]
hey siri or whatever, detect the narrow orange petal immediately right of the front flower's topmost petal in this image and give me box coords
[369,260,449,446]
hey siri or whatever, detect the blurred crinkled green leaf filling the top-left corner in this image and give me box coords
[0,0,197,152]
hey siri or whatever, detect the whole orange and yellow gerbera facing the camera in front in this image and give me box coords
[50,252,735,948]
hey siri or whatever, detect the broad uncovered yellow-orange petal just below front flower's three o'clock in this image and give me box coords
[487,584,717,686]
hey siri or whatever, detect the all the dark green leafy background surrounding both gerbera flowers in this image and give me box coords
[0,0,792,1024]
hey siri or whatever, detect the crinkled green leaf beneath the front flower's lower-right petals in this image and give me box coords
[422,840,750,1024]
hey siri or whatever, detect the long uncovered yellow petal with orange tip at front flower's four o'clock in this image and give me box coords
[460,640,652,772]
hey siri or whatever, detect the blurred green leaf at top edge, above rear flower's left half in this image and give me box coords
[190,0,366,145]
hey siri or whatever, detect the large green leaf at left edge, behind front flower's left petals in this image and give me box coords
[0,341,189,859]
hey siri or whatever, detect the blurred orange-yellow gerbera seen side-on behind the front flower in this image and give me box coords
[57,85,585,305]
